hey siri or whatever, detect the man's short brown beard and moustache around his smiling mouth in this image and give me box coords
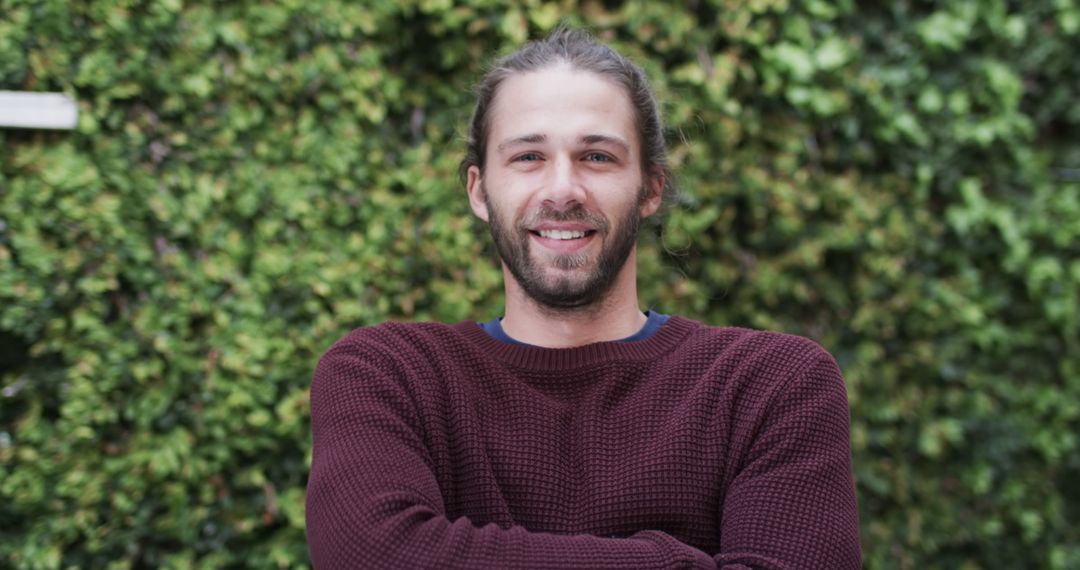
[482,182,645,311]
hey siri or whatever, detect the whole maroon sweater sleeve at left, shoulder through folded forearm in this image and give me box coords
[306,342,716,569]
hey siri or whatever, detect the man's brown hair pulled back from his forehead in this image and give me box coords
[458,26,675,218]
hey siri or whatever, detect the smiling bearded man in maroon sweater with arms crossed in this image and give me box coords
[307,30,860,569]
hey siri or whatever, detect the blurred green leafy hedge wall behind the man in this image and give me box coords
[0,0,1080,569]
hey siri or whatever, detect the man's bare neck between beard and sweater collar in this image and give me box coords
[502,255,647,349]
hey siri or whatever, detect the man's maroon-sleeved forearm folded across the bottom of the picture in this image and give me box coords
[308,479,716,569]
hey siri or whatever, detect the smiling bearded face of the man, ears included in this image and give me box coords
[469,66,662,309]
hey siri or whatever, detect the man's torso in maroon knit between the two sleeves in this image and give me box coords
[334,317,822,552]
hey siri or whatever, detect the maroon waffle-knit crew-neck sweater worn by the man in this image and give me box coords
[307,316,860,570]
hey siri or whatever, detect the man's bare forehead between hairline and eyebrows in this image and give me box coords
[488,65,637,154]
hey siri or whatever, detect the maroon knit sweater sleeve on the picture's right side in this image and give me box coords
[715,349,861,570]
